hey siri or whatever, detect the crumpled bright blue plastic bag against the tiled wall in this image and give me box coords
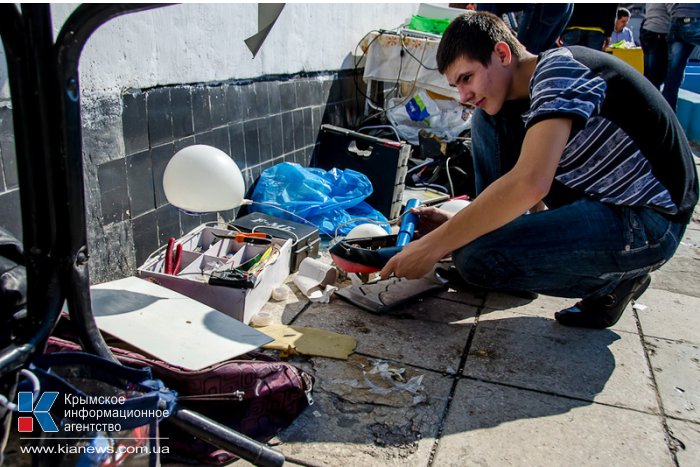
[250,162,391,236]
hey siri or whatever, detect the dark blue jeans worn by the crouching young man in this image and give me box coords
[462,107,685,298]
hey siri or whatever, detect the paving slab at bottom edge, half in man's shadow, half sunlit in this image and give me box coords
[433,380,674,467]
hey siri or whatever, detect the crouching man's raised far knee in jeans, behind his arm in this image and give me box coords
[472,101,529,196]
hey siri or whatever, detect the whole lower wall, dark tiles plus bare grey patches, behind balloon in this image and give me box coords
[0,71,365,283]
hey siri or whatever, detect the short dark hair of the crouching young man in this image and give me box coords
[436,11,526,74]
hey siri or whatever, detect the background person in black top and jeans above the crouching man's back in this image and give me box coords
[558,3,617,50]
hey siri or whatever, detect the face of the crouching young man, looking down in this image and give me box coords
[445,52,510,115]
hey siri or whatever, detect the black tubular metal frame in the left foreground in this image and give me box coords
[0,4,284,465]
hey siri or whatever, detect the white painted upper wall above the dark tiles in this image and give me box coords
[0,3,418,101]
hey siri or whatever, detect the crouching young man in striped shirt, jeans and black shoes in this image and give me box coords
[381,12,698,328]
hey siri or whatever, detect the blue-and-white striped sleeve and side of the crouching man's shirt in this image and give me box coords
[523,48,678,215]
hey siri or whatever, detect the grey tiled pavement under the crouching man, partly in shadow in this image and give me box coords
[242,154,700,466]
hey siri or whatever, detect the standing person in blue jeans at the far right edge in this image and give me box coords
[662,3,700,110]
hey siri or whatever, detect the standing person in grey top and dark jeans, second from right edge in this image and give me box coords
[639,3,671,89]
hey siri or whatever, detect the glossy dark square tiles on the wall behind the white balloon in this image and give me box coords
[108,72,364,266]
